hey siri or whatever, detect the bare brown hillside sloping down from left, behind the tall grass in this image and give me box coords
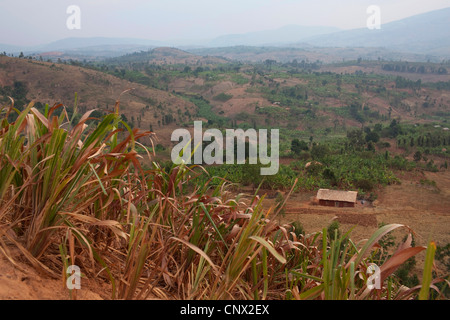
[0,56,196,146]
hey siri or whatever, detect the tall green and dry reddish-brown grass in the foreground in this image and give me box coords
[0,96,439,300]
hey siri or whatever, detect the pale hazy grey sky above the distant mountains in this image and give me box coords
[0,0,450,45]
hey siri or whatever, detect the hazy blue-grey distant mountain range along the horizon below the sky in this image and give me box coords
[0,7,450,61]
